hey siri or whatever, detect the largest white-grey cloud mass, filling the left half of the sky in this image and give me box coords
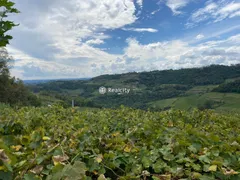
[8,0,142,78]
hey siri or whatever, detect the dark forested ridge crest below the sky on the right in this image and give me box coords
[91,64,240,86]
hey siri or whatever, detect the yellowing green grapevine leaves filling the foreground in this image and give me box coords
[0,106,240,180]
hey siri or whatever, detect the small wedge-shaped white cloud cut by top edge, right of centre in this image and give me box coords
[166,0,191,15]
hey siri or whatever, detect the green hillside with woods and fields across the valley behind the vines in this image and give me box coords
[29,64,240,110]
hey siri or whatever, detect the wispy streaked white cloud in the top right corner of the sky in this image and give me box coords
[186,0,240,28]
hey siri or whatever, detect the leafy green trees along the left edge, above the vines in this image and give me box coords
[0,0,40,106]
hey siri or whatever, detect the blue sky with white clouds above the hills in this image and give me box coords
[7,0,240,80]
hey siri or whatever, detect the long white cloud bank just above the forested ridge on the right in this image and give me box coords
[121,34,240,69]
